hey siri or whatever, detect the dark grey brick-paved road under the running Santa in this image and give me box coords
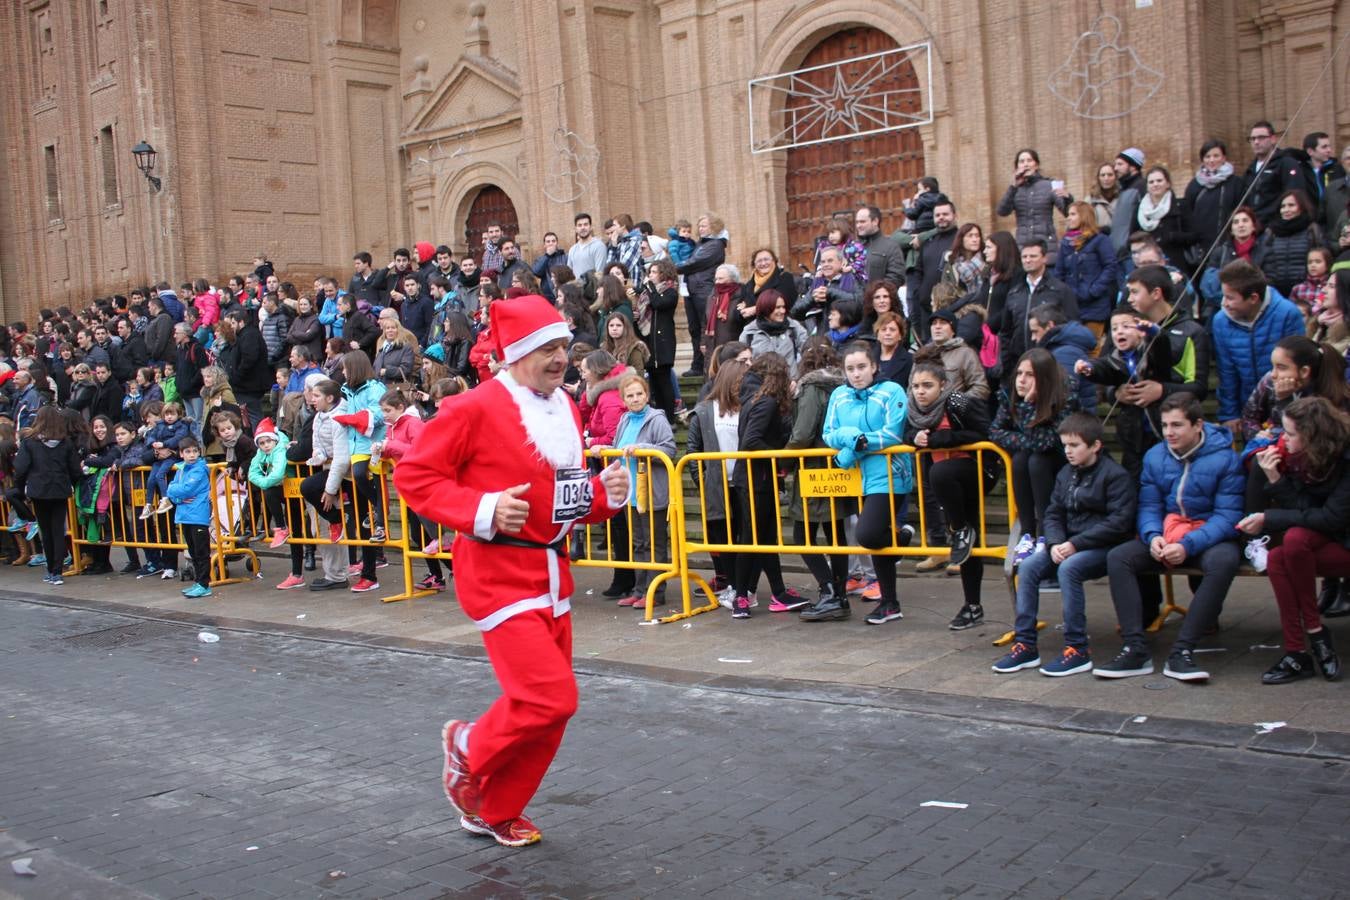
[0,600,1350,900]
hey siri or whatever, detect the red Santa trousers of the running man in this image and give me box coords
[468,610,576,824]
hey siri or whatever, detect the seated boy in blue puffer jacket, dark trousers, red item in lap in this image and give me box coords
[1092,391,1246,681]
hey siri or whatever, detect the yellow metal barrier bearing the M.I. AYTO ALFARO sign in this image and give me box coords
[675,441,1017,614]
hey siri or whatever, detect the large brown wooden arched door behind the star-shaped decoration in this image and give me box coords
[784,27,923,269]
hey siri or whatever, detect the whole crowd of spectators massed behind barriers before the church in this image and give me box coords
[0,121,1350,684]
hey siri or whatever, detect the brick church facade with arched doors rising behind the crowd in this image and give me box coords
[0,0,1350,320]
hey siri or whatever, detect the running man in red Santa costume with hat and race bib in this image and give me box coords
[394,296,629,847]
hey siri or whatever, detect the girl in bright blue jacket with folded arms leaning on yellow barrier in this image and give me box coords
[802,343,914,625]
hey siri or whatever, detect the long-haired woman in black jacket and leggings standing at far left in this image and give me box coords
[14,406,84,584]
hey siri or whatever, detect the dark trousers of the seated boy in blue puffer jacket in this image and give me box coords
[1106,540,1242,650]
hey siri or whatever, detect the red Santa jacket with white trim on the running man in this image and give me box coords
[394,372,622,631]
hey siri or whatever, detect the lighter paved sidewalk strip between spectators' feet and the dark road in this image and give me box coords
[0,553,1350,754]
